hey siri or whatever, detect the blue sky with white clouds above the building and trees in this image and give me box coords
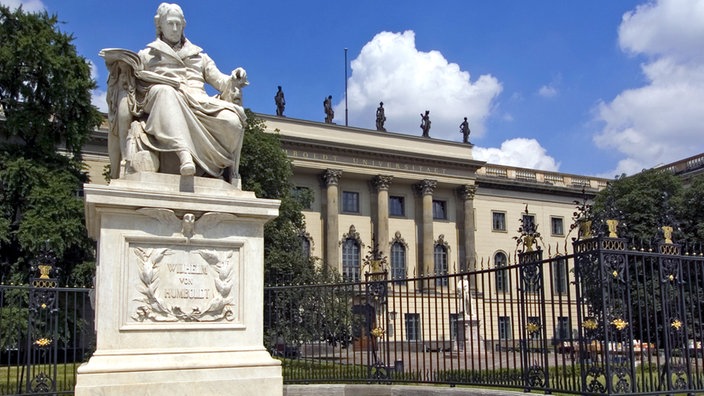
[0,0,704,178]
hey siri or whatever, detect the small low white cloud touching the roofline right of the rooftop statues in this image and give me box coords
[473,138,560,172]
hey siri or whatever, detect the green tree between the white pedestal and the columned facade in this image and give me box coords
[240,110,352,350]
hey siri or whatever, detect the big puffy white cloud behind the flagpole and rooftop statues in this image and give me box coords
[335,31,502,141]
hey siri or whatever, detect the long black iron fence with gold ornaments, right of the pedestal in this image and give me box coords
[264,237,704,395]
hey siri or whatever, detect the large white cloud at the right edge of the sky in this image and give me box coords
[594,0,704,176]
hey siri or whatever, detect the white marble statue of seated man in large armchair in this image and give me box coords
[100,3,248,185]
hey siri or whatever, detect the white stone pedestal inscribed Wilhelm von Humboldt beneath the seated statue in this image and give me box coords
[75,173,283,396]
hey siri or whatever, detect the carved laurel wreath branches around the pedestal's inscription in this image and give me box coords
[132,247,235,322]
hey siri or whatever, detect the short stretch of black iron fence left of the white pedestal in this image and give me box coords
[0,282,95,395]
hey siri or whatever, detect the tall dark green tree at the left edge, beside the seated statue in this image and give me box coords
[0,6,102,283]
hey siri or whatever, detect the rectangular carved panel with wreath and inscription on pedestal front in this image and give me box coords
[126,242,242,324]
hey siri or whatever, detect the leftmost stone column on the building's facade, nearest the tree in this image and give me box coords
[321,169,342,270]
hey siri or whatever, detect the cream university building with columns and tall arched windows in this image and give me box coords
[84,114,607,341]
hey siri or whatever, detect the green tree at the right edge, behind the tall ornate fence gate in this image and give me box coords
[582,169,704,346]
